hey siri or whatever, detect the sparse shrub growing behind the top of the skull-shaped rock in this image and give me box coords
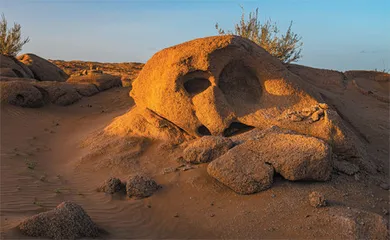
[215,7,303,63]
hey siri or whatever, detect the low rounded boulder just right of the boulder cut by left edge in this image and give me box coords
[33,81,81,106]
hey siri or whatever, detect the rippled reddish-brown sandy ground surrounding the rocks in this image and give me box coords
[0,83,390,239]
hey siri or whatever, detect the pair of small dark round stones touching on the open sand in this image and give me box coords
[99,175,161,199]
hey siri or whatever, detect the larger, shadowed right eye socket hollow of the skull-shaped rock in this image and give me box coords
[218,61,262,112]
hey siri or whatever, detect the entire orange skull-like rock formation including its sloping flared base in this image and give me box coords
[106,36,366,170]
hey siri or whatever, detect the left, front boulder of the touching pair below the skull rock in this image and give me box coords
[207,142,274,194]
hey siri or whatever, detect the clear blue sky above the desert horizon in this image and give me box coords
[0,0,390,70]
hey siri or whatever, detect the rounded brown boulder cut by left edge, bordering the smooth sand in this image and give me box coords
[0,81,44,108]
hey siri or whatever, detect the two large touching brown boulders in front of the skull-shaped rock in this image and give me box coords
[207,127,332,194]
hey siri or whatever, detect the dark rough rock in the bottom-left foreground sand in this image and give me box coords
[19,202,99,239]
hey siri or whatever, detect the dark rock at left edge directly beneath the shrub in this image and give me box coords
[0,54,34,78]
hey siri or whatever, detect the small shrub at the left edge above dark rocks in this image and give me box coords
[0,14,30,56]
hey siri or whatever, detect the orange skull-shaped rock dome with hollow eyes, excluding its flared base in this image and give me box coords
[131,36,318,136]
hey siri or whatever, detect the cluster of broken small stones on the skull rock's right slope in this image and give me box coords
[282,103,329,123]
